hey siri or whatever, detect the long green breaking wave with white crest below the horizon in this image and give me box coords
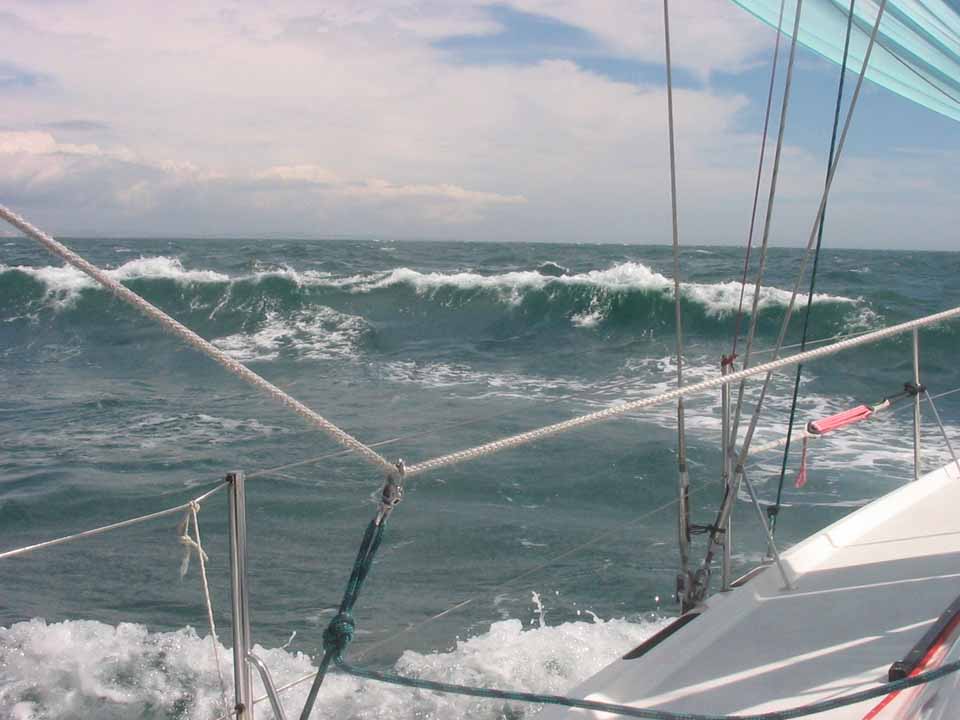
[0,256,876,350]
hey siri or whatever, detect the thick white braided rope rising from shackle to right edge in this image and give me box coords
[405,307,960,478]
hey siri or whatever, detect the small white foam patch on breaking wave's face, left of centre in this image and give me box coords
[213,306,369,362]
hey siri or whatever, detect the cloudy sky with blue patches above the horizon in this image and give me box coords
[0,0,960,249]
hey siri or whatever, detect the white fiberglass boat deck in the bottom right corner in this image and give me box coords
[544,464,960,720]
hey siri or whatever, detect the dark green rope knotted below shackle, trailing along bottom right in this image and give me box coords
[300,504,960,720]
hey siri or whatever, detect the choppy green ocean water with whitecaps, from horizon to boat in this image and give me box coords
[0,239,960,720]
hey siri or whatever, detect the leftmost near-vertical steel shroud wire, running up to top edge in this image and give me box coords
[663,0,690,608]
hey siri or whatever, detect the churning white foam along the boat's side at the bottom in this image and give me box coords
[0,619,666,720]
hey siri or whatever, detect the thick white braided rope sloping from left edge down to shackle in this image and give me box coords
[0,205,393,471]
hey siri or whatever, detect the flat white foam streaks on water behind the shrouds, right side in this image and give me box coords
[384,356,960,490]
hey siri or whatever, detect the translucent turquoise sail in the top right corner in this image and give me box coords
[733,0,960,120]
